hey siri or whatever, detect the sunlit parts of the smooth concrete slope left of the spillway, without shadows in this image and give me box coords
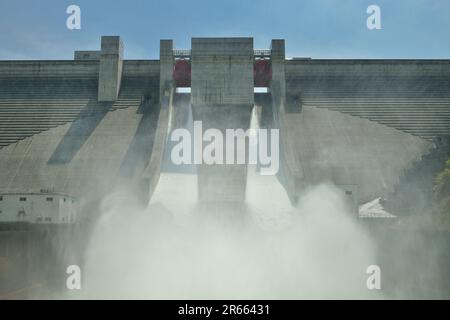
[0,102,143,206]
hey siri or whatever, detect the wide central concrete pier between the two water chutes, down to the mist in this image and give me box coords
[191,38,254,206]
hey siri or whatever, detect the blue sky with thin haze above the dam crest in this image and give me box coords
[0,0,450,60]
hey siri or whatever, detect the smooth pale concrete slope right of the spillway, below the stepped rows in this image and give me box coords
[282,107,433,203]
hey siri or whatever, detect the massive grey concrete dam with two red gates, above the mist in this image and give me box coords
[0,36,450,294]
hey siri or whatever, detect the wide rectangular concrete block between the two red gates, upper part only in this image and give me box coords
[191,38,253,106]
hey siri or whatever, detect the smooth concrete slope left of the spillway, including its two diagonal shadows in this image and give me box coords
[0,91,170,214]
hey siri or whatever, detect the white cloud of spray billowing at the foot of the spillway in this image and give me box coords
[76,167,381,299]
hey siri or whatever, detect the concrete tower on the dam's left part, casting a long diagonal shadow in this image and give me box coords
[98,36,123,102]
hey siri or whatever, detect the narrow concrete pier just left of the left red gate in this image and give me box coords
[159,40,173,107]
